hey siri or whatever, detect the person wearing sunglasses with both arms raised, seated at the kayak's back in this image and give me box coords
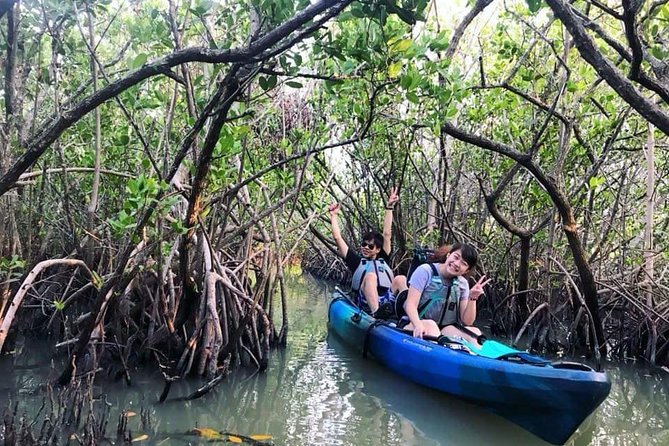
[329,188,407,315]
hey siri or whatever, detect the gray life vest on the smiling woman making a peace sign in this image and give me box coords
[418,263,460,327]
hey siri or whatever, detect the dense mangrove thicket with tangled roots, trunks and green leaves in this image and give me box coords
[0,0,669,404]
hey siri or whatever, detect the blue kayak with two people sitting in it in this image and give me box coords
[329,298,611,444]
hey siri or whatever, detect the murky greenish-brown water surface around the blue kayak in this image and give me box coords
[0,277,669,446]
